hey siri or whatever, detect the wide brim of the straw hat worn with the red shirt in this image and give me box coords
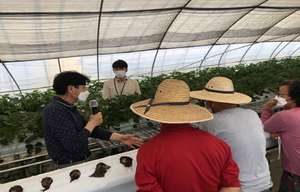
[130,99,213,124]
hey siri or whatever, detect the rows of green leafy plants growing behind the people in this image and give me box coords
[0,57,300,156]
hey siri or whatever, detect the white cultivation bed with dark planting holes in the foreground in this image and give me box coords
[0,149,137,192]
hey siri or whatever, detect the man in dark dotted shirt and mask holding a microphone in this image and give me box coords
[42,71,143,168]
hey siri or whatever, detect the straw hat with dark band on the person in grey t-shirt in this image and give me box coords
[190,77,252,104]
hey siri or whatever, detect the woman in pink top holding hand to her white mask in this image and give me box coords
[261,79,300,192]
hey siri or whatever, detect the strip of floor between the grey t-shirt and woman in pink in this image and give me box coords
[267,148,282,192]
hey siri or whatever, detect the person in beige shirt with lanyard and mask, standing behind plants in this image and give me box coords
[102,60,141,99]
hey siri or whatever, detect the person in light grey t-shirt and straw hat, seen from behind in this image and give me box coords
[191,77,272,192]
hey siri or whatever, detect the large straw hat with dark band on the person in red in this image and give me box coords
[130,79,212,124]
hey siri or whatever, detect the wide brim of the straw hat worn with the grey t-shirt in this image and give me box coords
[190,90,252,104]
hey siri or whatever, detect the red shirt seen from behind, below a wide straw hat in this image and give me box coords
[135,124,241,192]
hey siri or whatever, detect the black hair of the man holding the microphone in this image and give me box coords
[52,71,91,95]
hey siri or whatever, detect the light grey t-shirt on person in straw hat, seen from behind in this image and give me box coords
[201,108,271,192]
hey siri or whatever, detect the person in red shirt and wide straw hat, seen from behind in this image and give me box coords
[130,79,241,192]
